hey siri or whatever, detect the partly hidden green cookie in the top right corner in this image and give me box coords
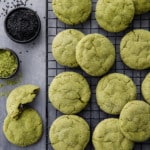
[133,0,150,15]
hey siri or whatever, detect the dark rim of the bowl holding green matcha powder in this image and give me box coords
[0,48,20,79]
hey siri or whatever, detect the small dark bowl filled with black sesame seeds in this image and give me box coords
[4,7,41,43]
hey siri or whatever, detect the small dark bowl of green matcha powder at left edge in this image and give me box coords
[0,48,19,79]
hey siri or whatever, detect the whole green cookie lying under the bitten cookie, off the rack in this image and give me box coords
[3,108,43,147]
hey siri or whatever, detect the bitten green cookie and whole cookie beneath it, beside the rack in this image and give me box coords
[3,84,43,147]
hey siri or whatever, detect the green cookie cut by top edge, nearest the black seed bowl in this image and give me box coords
[52,0,92,25]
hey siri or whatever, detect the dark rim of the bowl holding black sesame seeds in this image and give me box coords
[4,7,41,43]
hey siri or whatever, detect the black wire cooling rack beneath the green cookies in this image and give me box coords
[46,0,150,150]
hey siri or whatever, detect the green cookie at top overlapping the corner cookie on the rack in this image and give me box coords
[95,0,135,32]
